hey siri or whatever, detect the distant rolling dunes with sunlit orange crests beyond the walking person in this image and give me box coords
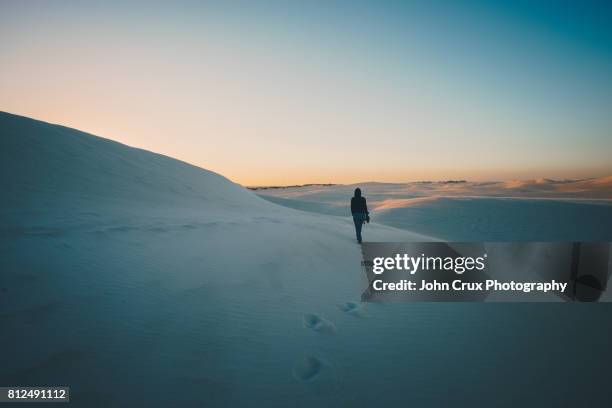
[258,177,612,241]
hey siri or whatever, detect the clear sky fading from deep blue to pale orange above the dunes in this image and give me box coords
[0,0,612,185]
